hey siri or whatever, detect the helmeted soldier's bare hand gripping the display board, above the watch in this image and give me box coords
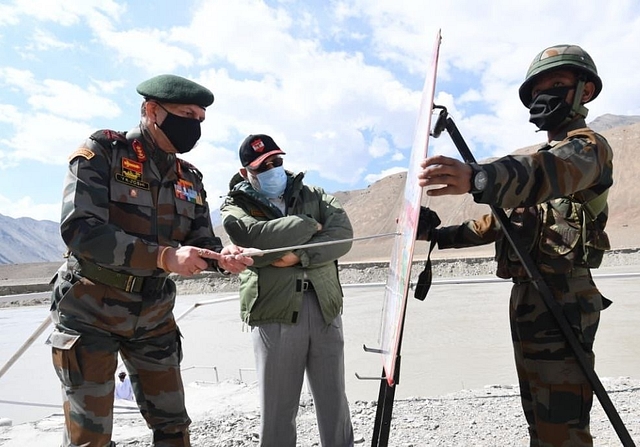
[418,155,472,196]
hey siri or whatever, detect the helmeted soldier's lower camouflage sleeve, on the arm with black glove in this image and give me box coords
[436,214,500,250]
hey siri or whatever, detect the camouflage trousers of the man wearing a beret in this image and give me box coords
[47,272,191,447]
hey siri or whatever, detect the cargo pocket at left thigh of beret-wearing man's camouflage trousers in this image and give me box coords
[46,329,84,387]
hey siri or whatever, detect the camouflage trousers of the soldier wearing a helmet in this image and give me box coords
[510,276,602,447]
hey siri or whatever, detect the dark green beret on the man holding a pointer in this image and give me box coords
[136,75,213,107]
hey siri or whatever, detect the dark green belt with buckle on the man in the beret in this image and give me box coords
[77,260,167,295]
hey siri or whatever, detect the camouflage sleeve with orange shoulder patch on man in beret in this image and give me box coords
[60,139,158,270]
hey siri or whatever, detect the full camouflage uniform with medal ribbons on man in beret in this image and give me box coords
[49,123,222,446]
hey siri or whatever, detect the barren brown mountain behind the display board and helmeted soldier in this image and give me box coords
[335,123,640,262]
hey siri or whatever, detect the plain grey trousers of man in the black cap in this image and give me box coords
[252,290,353,447]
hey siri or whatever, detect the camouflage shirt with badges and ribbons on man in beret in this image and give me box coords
[60,127,222,276]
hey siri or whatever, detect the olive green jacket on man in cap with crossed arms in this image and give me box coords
[221,172,353,326]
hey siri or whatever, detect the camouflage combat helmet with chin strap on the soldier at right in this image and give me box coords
[519,44,602,109]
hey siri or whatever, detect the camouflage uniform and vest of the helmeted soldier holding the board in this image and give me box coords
[436,119,613,447]
